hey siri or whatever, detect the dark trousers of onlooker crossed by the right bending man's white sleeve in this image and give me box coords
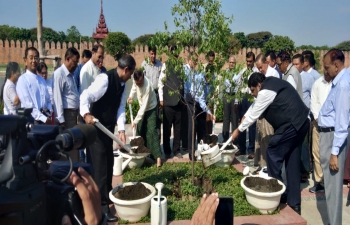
[238,98,256,154]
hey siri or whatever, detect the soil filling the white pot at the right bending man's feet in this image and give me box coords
[244,177,283,193]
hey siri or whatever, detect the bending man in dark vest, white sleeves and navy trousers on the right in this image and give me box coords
[232,73,310,214]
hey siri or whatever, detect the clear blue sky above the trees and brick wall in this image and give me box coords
[0,0,350,47]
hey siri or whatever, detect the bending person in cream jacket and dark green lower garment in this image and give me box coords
[128,70,162,167]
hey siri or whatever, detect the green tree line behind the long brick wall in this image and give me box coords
[0,25,350,59]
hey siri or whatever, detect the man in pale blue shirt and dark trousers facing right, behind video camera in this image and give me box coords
[53,47,80,162]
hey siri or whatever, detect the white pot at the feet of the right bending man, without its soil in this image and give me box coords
[241,177,286,214]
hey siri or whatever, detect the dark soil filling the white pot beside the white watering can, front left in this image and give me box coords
[114,182,151,200]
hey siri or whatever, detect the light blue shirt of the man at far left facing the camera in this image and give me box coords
[16,70,52,123]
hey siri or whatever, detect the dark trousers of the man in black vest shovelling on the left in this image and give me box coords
[89,124,115,213]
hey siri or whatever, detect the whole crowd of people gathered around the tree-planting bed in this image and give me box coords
[1,44,350,224]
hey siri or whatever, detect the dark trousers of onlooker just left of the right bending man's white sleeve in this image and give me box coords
[222,98,238,142]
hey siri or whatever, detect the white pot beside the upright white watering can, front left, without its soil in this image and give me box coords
[109,182,156,223]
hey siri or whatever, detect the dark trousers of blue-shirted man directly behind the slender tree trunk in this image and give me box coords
[187,95,207,154]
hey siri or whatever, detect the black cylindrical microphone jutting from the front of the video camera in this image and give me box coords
[56,124,97,151]
